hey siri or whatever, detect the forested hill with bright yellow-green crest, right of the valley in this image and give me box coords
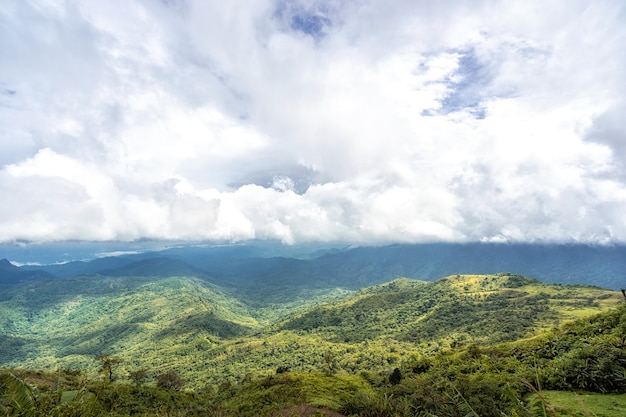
[280,274,621,343]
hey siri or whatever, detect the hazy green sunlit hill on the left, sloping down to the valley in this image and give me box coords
[0,276,259,367]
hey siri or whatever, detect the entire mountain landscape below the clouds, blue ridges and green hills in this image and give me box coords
[0,240,626,417]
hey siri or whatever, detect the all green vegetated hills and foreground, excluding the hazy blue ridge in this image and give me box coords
[0,274,626,417]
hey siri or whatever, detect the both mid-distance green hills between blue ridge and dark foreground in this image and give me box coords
[0,270,621,384]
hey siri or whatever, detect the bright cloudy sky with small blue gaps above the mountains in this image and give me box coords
[0,0,626,244]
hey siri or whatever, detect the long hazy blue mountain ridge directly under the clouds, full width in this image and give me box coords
[0,243,626,289]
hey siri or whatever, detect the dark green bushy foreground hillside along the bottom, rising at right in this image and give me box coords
[0,290,626,417]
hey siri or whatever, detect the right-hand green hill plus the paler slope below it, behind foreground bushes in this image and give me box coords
[183,274,622,382]
